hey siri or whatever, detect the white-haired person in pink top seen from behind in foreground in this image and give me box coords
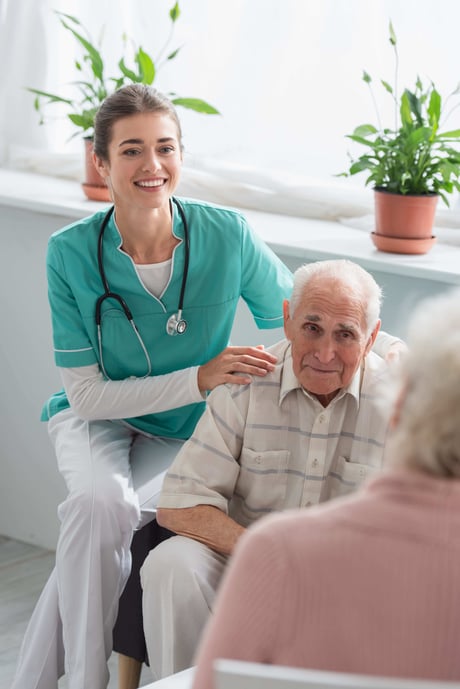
[193,290,460,689]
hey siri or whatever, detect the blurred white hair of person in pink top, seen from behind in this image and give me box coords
[387,288,460,478]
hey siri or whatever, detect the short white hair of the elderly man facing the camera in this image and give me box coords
[289,259,382,336]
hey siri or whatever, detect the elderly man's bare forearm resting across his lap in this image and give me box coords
[156,505,245,555]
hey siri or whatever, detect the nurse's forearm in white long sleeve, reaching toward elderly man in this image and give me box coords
[59,364,203,421]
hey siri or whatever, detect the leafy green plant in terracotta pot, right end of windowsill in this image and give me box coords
[343,22,460,253]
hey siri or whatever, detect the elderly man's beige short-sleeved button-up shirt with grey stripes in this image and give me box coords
[159,340,389,526]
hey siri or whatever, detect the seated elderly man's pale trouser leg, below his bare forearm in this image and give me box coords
[141,536,228,680]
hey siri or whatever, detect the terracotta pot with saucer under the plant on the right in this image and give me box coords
[372,189,438,254]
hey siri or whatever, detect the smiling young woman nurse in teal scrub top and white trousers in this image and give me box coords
[13,84,292,689]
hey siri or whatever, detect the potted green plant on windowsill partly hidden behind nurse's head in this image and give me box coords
[28,2,219,201]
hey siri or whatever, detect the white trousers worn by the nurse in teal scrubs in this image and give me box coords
[12,410,183,689]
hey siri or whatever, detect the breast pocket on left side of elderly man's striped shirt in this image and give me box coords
[236,448,290,519]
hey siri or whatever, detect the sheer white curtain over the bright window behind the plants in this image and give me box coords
[0,0,460,217]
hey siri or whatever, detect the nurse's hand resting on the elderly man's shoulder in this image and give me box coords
[198,345,277,392]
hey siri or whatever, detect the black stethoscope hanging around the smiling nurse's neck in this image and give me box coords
[95,197,190,378]
